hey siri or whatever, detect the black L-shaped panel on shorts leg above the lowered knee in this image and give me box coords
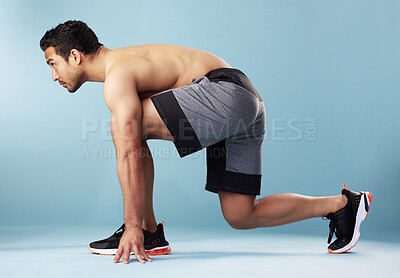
[205,140,261,195]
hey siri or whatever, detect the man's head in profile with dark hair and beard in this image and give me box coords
[40,20,103,93]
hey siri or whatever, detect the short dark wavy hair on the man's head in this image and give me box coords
[40,20,103,61]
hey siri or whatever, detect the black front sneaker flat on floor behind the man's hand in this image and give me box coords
[89,221,171,255]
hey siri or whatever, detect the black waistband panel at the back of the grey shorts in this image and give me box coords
[205,68,262,101]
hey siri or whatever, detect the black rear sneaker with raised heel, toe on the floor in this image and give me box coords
[326,184,372,254]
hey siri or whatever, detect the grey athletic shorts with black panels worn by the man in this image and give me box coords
[151,68,265,195]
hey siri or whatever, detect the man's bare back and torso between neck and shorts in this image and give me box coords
[105,44,230,99]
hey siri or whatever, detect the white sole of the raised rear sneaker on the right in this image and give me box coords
[328,191,372,254]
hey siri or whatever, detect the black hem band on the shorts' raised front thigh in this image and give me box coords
[150,90,202,157]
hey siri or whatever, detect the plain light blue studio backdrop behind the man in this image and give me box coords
[0,0,400,239]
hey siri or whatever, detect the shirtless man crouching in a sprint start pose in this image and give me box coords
[40,21,372,263]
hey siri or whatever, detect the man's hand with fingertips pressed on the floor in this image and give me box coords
[114,229,151,264]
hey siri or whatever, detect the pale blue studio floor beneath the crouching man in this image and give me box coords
[0,226,400,278]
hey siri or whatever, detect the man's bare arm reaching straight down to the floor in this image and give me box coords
[104,68,151,263]
